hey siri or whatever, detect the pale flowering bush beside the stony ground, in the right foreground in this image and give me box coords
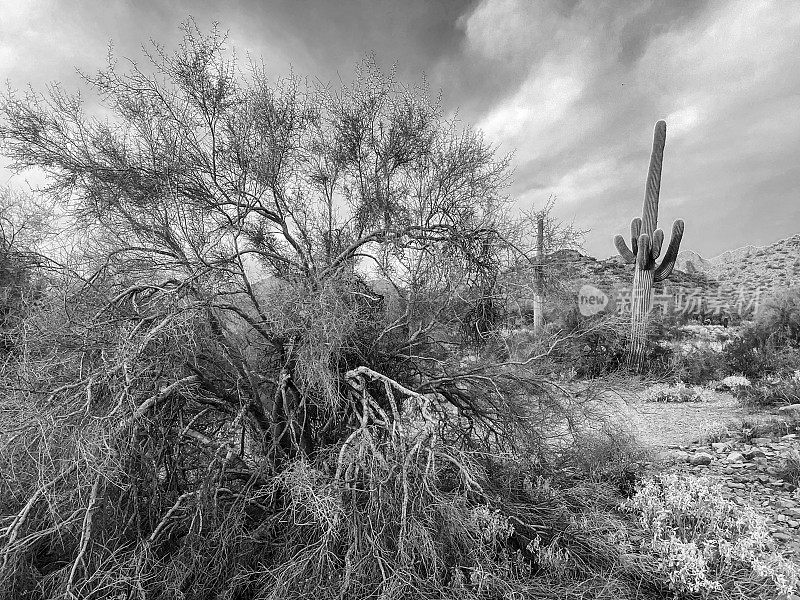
[622,474,800,598]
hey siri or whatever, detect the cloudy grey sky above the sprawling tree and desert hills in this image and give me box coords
[0,0,800,258]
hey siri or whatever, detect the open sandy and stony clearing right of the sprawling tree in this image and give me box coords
[617,386,800,563]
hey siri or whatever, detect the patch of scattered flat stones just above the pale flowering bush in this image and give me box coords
[664,433,800,562]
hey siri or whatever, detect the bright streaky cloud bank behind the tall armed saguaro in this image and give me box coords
[456,0,800,255]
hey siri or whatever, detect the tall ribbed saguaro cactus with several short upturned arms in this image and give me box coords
[614,121,684,370]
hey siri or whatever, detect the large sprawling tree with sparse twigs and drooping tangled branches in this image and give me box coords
[0,23,608,597]
